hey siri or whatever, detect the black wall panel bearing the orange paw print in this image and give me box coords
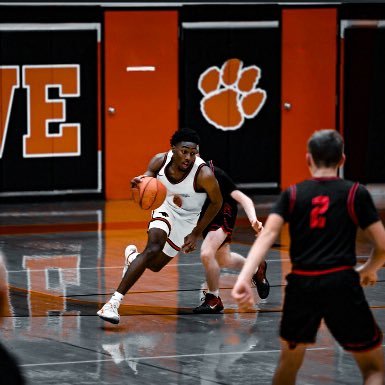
[181,21,281,187]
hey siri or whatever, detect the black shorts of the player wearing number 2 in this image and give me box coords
[280,269,382,352]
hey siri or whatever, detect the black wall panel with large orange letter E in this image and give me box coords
[0,26,101,196]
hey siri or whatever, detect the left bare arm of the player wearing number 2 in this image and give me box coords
[231,214,284,309]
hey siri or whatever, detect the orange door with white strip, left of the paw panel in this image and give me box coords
[105,11,178,199]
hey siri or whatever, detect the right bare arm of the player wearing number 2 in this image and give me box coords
[356,221,385,286]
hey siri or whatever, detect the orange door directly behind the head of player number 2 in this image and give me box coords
[281,8,337,189]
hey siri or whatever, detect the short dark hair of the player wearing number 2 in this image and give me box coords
[307,130,344,167]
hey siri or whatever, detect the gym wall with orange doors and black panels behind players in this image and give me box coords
[0,2,385,200]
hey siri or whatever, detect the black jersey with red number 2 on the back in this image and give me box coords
[271,177,379,270]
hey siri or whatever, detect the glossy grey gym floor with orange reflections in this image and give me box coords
[0,195,385,385]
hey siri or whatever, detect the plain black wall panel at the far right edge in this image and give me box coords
[344,26,385,183]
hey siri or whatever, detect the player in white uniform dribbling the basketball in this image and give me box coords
[97,129,222,324]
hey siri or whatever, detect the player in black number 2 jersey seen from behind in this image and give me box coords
[232,130,385,385]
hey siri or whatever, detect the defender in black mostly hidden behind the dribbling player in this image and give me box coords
[194,161,270,314]
